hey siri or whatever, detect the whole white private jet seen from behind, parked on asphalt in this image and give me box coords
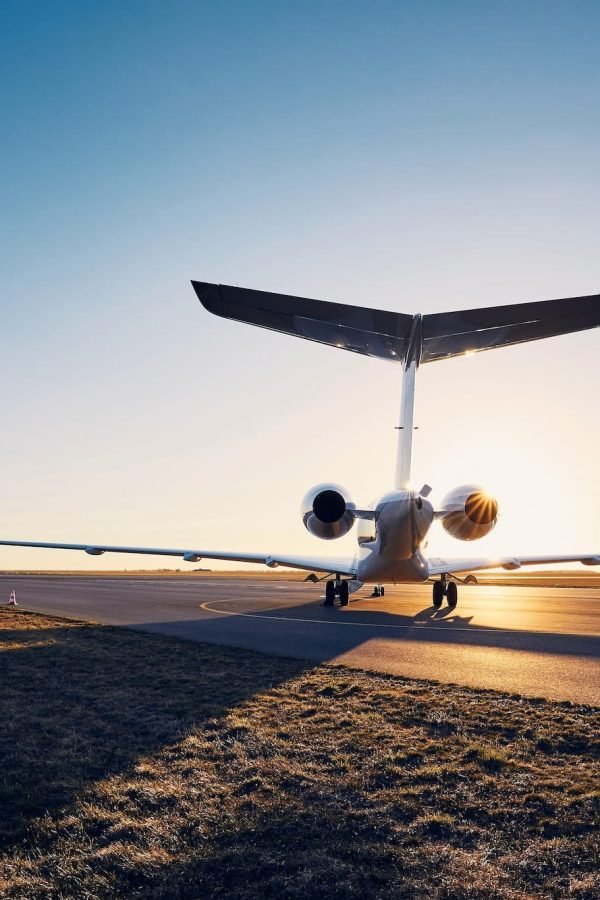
[0,281,600,608]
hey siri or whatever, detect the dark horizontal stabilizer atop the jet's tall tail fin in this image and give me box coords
[192,281,600,363]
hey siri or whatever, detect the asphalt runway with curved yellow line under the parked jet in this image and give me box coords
[0,575,600,705]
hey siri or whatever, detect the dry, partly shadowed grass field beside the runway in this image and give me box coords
[0,608,600,900]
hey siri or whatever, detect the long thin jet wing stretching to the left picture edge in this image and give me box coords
[0,541,356,576]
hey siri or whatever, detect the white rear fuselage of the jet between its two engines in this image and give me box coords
[356,490,433,584]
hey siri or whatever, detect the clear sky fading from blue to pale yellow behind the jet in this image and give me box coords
[0,0,600,568]
